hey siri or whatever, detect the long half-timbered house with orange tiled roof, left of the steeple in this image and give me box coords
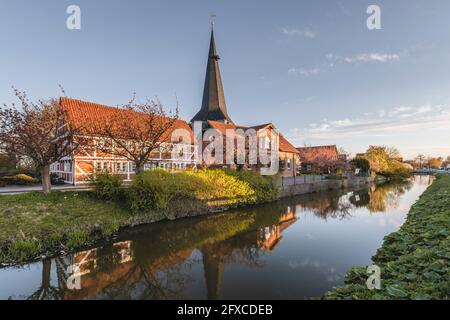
[51,97,197,185]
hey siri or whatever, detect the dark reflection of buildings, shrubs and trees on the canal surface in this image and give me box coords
[24,179,426,299]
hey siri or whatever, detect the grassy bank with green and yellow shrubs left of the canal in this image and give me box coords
[0,170,278,264]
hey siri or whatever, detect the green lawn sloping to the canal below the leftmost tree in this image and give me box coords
[0,192,154,263]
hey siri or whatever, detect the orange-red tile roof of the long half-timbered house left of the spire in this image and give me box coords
[60,97,195,143]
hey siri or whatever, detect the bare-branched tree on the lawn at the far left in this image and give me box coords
[0,88,81,193]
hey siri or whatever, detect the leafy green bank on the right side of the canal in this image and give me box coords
[323,174,450,300]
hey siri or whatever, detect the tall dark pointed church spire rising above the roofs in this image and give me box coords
[192,16,233,123]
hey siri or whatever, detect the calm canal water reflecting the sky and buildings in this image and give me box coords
[0,176,431,299]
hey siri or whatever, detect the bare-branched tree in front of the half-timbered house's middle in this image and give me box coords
[102,97,178,174]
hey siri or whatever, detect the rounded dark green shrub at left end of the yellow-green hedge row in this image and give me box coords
[90,172,124,200]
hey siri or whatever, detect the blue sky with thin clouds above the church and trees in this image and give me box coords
[0,0,450,158]
